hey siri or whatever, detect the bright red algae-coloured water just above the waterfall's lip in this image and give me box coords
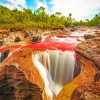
[26,40,76,51]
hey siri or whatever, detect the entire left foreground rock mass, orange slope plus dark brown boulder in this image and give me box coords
[0,47,52,100]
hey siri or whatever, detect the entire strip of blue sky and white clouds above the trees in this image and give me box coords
[0,0,100,20]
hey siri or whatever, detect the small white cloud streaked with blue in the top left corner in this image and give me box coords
[0,0,27,10]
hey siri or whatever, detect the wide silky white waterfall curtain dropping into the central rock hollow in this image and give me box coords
[34,50,75,94]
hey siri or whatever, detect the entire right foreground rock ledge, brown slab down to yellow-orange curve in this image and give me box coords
[56,38,100,100]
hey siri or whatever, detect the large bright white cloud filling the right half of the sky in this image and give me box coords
[51,0,100,20]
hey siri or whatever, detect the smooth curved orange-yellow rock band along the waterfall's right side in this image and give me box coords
[56,55,98,100]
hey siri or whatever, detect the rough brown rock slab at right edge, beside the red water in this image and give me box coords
[75,38,100,69]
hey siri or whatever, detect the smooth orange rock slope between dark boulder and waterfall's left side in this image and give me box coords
[0,47,50,100]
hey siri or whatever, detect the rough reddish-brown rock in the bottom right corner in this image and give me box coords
[71,82,100,100]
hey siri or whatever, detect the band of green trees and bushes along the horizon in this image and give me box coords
[0,5,100,30]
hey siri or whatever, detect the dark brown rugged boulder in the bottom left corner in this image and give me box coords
[0,65,42,100]
